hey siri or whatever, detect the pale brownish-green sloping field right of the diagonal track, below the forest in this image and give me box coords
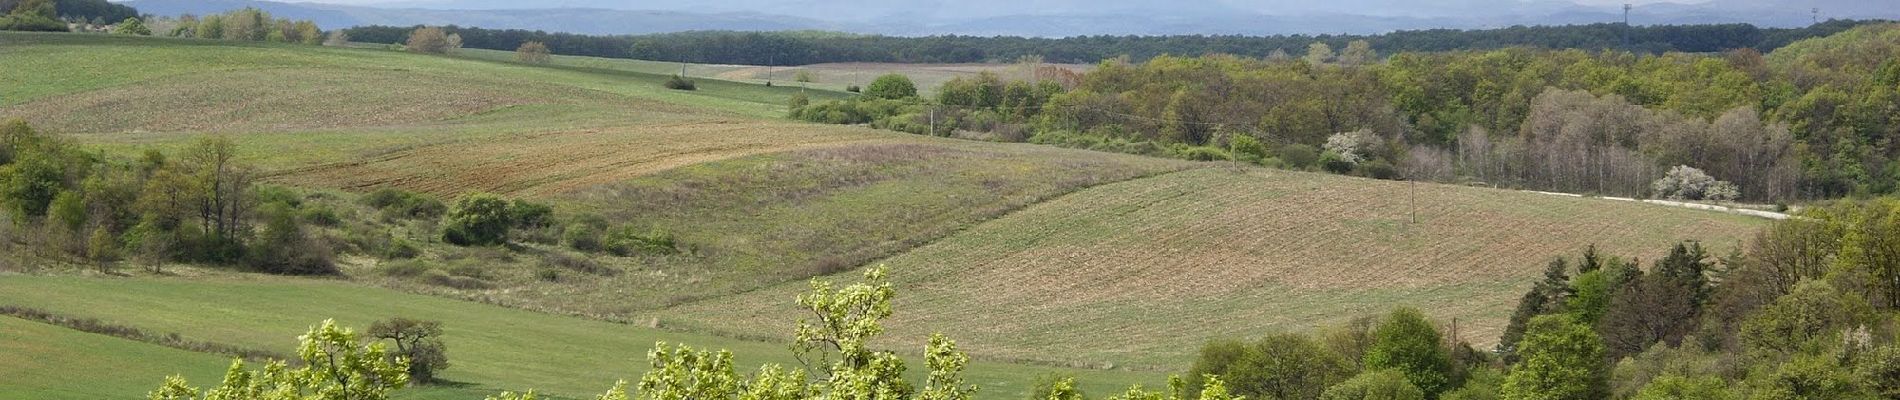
[663,169,1761,368]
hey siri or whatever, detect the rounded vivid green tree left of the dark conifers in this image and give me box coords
[1366,307,1455,398]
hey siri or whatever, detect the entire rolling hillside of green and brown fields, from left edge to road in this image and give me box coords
[0,32,1759,398]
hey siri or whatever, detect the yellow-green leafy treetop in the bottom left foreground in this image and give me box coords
[150,320,409,400]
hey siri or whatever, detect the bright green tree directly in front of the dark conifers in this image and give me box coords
[1499,315,1609,400]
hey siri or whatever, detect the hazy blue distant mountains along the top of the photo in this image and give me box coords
[125,0,1900,36]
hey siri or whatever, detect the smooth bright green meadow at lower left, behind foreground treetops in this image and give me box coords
[0,277,1161,398]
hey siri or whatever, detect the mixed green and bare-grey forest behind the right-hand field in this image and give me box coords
[792,25,1900,201]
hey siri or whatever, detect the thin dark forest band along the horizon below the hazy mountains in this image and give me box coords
[348,21,1870,64]
